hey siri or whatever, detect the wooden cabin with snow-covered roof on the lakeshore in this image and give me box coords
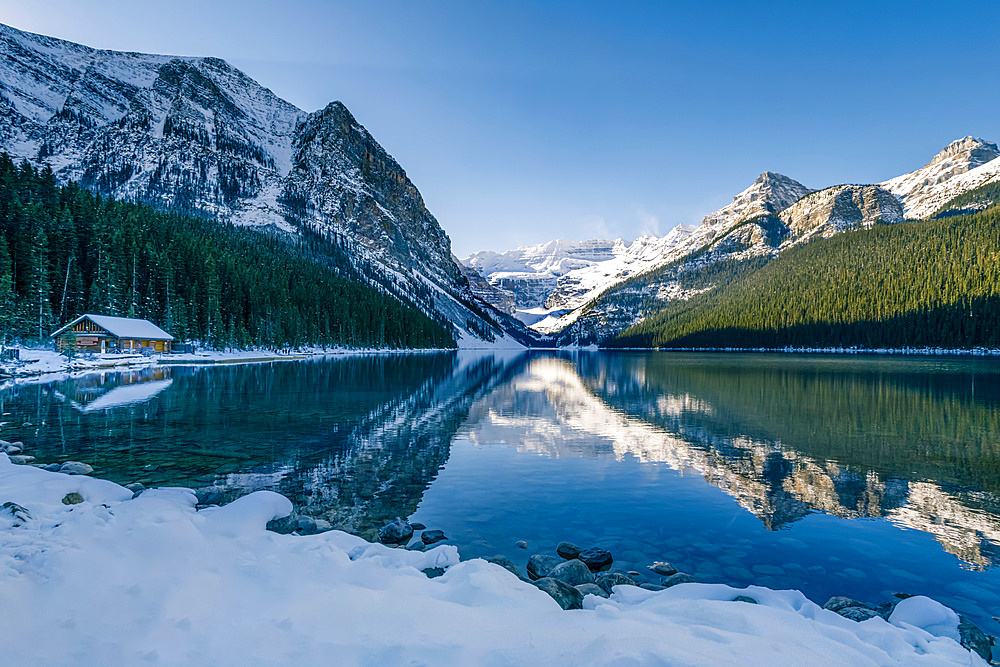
[50,315,174,353]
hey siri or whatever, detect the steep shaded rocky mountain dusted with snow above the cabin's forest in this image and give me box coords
[0,25,530,344]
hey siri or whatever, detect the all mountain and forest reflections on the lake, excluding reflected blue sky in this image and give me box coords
[0,353,1000,568]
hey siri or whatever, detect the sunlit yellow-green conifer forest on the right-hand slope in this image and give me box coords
[605,200,1000,349]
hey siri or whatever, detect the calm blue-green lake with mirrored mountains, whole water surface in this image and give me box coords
[0,352,1000,634]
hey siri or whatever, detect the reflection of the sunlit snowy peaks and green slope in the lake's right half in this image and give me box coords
[469,353,1000,568]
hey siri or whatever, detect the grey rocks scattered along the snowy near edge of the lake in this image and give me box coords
[0,440,996,664]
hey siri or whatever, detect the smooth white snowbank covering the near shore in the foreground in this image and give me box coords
[0,454,986,665]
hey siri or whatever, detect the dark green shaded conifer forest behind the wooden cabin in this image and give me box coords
[0,154,455,348]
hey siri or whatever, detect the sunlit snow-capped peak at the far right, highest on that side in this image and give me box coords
[879,137,1000,219]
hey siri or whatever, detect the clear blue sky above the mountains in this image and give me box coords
[0,0,1000,257]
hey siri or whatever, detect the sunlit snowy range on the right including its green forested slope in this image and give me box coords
[465,137,1000,348]
